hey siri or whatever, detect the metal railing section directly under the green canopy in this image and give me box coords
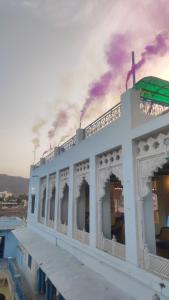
[140,100,169,117]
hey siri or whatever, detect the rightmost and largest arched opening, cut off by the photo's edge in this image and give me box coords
[144,162,169,259]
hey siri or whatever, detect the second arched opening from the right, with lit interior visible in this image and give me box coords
[101,174,125,244]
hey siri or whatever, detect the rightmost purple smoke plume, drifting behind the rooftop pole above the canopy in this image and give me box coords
[126,33,169,89]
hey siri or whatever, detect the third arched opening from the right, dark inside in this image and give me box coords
[77,179,90,232]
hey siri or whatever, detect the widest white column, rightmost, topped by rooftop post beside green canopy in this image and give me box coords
[121,89,141,265]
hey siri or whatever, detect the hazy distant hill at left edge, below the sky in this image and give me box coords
[0,174,29,196]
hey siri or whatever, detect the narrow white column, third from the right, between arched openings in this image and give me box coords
[67,165,74,238]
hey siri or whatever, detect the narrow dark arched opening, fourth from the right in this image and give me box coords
[60,183,69,225]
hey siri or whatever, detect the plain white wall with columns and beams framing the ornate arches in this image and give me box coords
[28,90,169,300]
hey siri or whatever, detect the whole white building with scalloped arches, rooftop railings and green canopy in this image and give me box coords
[14,77,169,300]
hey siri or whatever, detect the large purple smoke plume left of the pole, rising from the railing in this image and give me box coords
[80,34,129,120]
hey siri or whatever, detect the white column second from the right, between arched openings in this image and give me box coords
[89,156,96,247]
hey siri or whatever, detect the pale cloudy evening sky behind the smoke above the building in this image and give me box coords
[0,0,169,177]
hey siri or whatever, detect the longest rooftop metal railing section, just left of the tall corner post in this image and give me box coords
[84,103,120,138]
